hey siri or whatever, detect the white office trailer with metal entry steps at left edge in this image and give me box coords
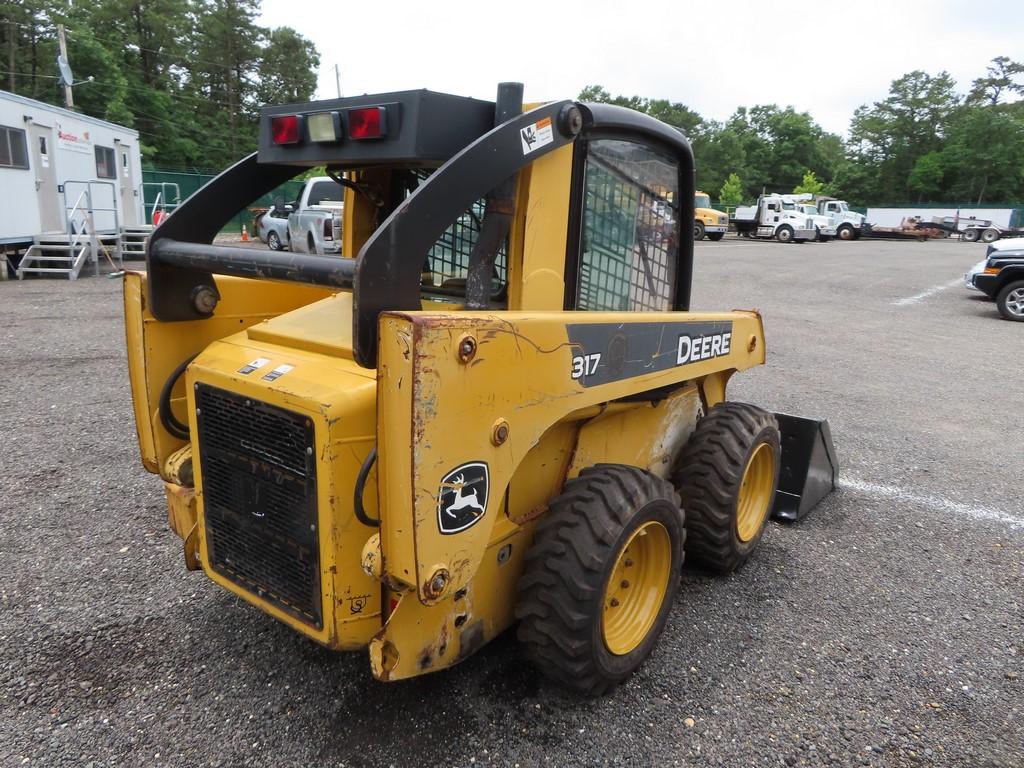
[0,90,150,279]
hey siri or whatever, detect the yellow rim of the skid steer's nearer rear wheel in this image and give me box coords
[601,520,672,656]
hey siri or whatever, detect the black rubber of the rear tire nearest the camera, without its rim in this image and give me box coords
[516,464,686,696]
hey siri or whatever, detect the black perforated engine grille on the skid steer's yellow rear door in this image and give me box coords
[196,384,323,629]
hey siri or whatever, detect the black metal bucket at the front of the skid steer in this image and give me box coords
[772,414,839,522]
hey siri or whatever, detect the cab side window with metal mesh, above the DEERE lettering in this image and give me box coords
[575,139,690,311]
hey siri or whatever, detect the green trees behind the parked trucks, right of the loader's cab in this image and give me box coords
[580,56,1024,205]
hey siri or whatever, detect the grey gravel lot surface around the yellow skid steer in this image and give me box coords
[0,239,1024,768]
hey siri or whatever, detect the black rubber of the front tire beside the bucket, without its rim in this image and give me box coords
[673,402,781,573]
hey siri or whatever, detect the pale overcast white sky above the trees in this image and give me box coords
[260,0,1024,134]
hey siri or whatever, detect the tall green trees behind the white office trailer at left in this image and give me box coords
[0,0,319,171]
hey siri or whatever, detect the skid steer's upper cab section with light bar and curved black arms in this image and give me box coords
[147,84,694,364]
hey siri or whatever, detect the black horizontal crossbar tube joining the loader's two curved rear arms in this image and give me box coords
[150,238,355,288]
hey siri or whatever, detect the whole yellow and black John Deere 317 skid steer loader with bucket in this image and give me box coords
[125,84,835,694]
